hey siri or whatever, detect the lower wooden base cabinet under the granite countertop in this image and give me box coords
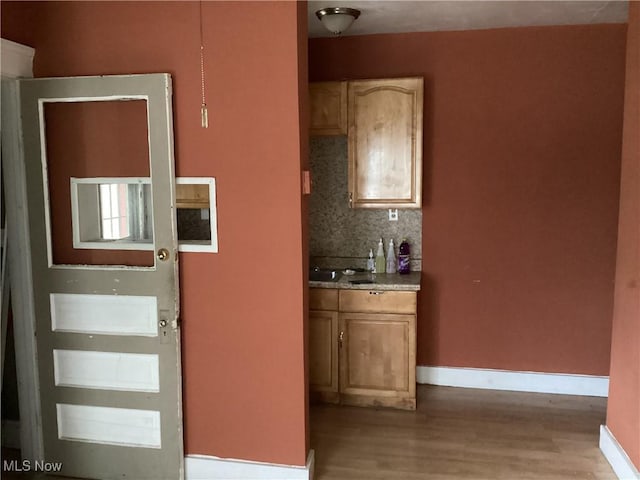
[309,289,417,410]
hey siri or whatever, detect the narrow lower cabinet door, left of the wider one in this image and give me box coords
[309,310,339,403]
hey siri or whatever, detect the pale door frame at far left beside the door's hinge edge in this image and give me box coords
[2,39,44,462]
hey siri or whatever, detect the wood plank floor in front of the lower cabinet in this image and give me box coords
[311,385,617,480]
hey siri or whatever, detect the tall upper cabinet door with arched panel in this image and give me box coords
[348,78,423,208]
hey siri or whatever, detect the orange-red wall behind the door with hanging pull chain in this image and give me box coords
[1,1,308,465]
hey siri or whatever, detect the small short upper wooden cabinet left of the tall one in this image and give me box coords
[309,82,347,135]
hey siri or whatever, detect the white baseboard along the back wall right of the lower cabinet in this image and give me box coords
[416,367,609,397]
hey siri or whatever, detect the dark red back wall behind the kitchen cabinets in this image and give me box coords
[309,23,626,375]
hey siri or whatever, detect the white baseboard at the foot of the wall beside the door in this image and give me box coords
[184,450,315,480]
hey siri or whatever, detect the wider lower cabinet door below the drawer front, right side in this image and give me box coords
[339,313,416,410]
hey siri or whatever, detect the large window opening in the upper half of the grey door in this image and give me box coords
[43,100,154,267]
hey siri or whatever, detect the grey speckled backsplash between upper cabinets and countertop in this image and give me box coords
[309,136,422,271]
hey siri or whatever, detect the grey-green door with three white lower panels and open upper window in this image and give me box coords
[20,74,183,480]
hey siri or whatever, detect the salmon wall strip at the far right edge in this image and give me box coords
[607,2,640,470]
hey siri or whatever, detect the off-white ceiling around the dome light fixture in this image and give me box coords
[308,0,628,38]
